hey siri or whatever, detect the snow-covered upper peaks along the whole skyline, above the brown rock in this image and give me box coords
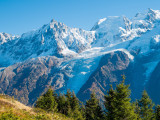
[0,9,160,65]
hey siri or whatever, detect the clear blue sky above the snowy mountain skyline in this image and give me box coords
[0,0,160,35]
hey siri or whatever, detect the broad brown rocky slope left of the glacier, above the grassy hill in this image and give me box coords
[0,57,68,104]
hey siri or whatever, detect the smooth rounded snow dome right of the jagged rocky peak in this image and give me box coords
[91,16,131,47]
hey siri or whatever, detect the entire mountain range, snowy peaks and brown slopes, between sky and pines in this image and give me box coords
[0,9,160,104]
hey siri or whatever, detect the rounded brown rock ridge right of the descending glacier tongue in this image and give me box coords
[77,51,130,101]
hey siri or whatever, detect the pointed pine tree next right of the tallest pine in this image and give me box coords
[138,90,154,120]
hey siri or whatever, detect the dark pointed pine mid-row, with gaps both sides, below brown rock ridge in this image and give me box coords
[85,93,104,120]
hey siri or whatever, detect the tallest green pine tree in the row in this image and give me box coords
[115,75,137,120]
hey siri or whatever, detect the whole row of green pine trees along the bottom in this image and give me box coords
[35,76,160,120]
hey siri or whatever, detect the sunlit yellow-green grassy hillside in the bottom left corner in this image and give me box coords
[0,94,71,120]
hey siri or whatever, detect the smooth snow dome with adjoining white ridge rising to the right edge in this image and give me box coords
[91,9,160,47]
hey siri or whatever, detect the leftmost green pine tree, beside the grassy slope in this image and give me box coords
[35,88,57,111]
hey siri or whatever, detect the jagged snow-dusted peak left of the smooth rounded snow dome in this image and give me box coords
[0,20,94,64]
